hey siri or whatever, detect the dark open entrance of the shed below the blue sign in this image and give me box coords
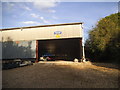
[38,38,82,60]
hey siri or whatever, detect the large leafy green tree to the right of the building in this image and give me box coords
[85,13,120,63]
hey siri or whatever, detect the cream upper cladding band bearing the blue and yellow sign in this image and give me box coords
[2,24,82,41]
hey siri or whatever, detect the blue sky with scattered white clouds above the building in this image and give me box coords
[0,0,118,39]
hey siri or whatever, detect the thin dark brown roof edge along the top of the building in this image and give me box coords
[0,22,83,31]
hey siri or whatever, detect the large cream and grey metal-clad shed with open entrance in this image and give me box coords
[0,23,83,61]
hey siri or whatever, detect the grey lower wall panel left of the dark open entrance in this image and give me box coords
[2,41,36,59]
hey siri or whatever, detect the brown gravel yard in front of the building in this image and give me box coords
[2,61,119,88]
